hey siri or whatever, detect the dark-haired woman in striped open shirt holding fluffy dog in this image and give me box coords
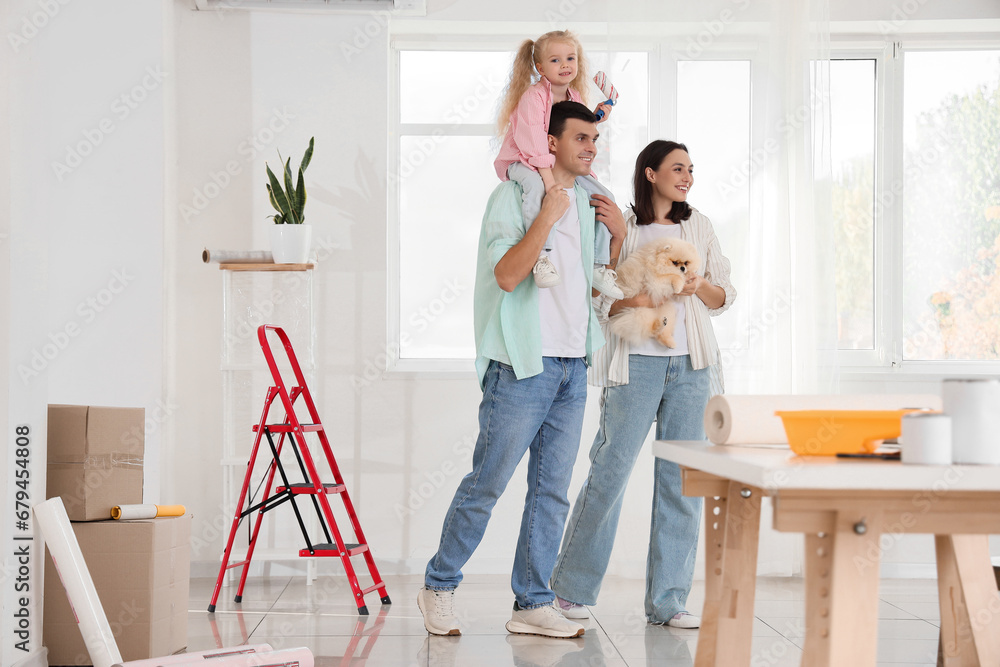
[552,140,736,628]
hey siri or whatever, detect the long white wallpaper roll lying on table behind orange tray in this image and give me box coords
[705,394,941,445]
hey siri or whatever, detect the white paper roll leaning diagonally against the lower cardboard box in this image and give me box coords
[33,496,122,667]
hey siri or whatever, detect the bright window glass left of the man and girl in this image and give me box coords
[389,50,510,366]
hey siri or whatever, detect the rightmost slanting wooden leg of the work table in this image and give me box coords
[934,535,1000,667]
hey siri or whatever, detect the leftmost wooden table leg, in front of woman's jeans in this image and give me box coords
[695,482,763,667]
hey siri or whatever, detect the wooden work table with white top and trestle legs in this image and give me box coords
[653,441,1000,667]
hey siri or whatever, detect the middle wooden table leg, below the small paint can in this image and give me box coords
[802,513,882,667]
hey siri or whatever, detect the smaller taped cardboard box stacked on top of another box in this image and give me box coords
[46,405,146,521]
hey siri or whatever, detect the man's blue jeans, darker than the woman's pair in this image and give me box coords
[424,357,587,609]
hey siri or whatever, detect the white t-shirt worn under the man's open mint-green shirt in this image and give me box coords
[538,188,590,357]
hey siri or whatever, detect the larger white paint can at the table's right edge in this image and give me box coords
[941,379,1000,465]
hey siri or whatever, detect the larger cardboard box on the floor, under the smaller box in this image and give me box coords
[42,516,191,665]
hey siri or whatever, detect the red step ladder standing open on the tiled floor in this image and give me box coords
[208,324,391,614]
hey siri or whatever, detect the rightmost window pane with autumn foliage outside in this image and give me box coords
[901,51,1000,360]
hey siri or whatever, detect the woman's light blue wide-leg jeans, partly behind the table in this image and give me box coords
[552,354,709,623]
